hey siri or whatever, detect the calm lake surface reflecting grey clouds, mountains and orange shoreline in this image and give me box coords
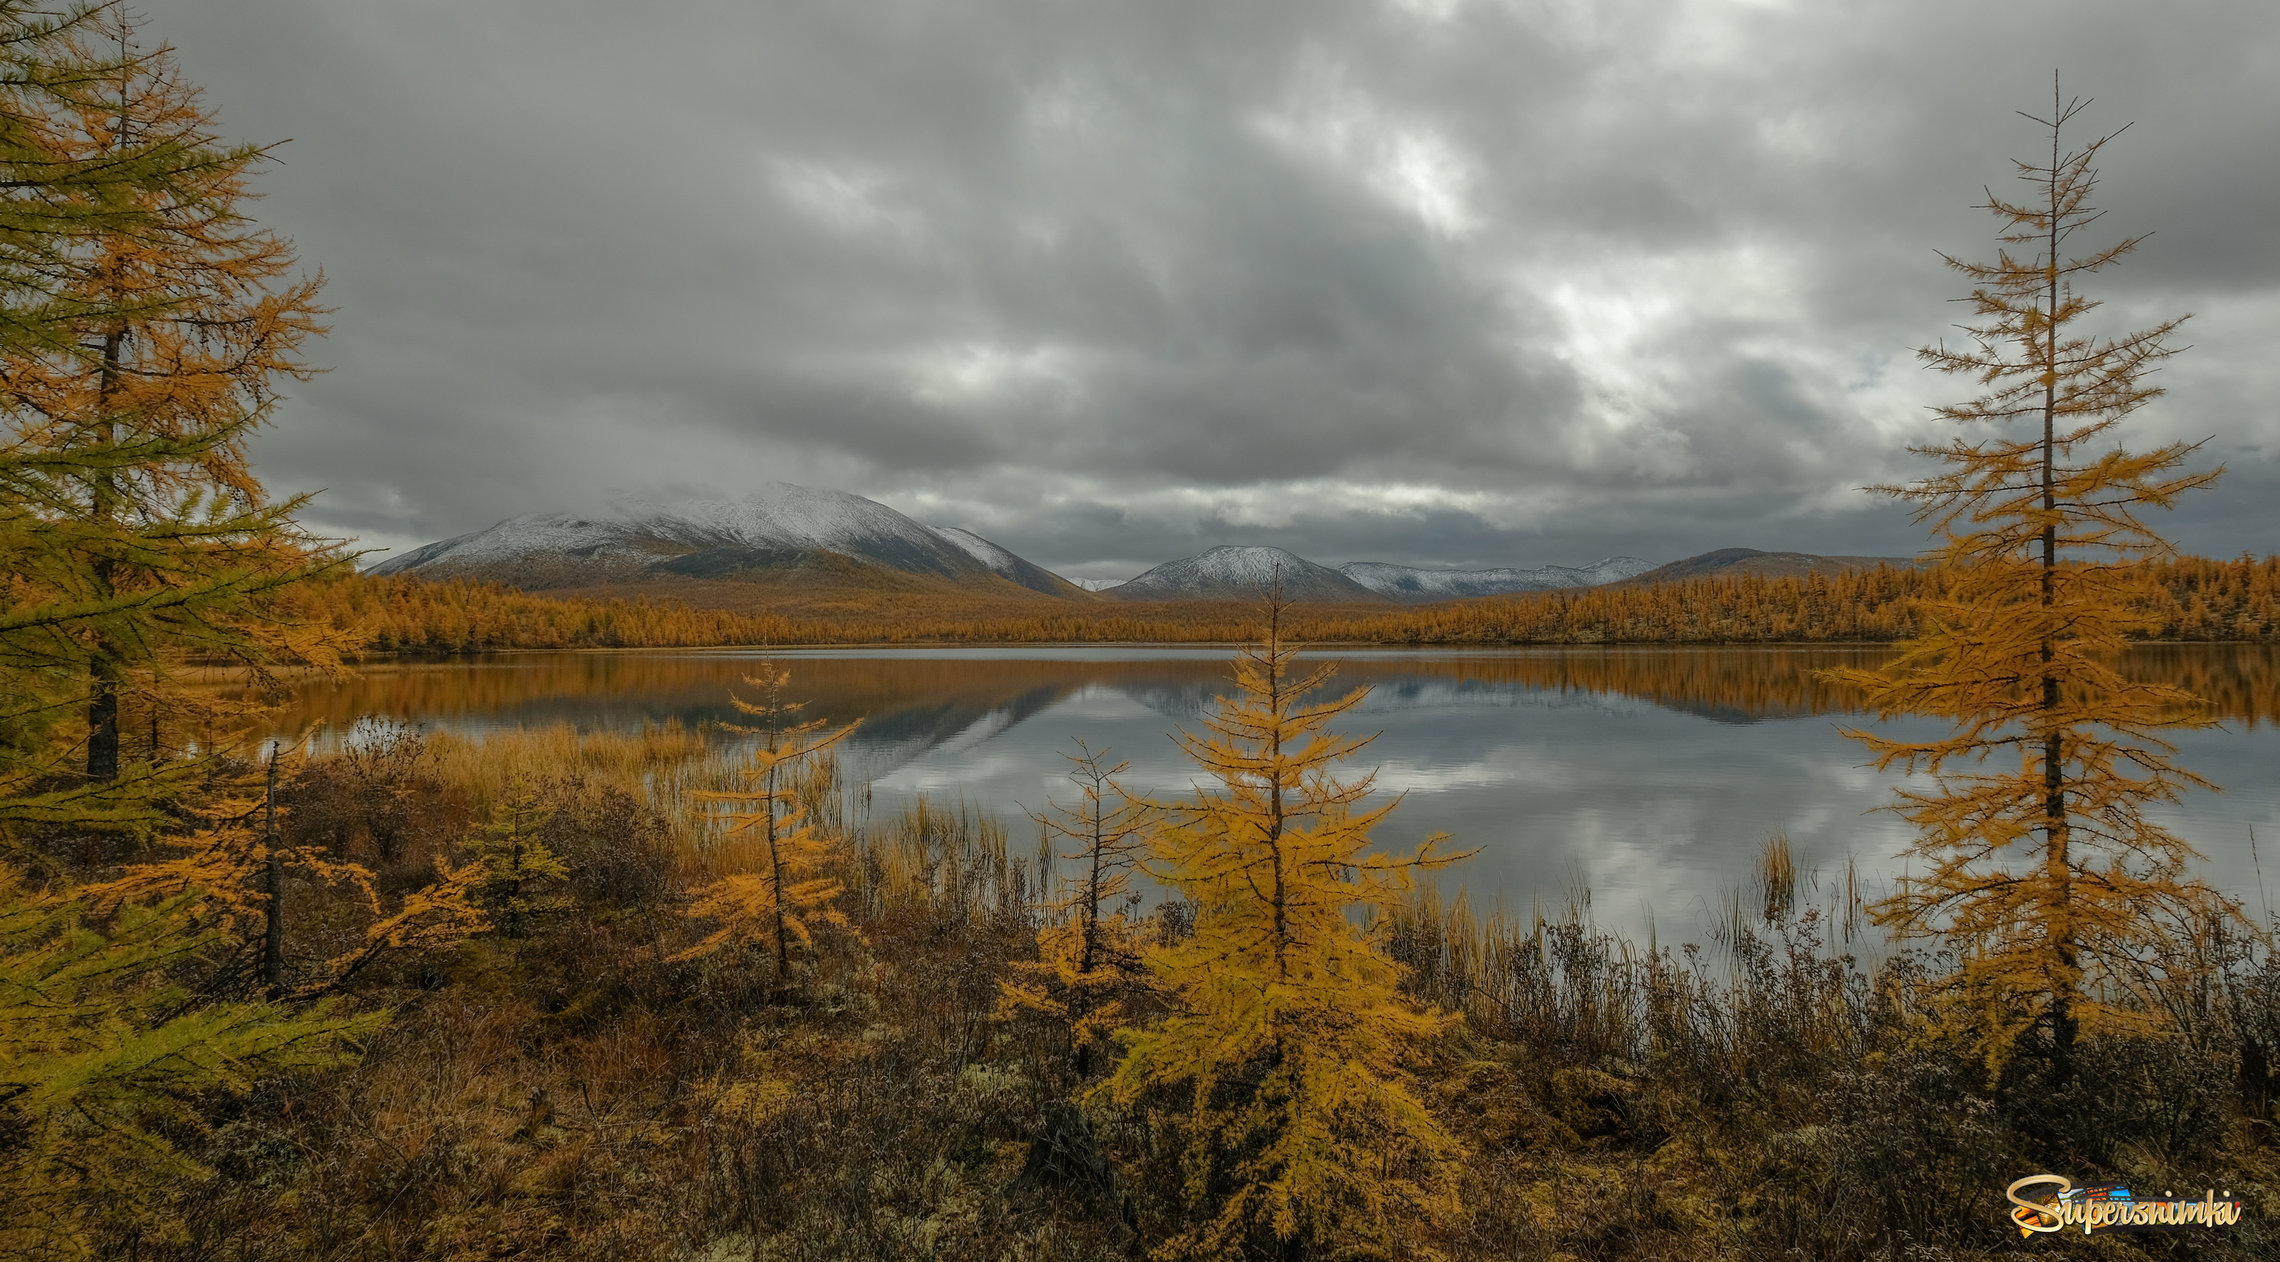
[287,645,2280,941]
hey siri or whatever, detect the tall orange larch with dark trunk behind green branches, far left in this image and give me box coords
[0,9,337,833]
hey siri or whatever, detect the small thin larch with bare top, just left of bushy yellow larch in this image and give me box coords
[999,738,1158,1077]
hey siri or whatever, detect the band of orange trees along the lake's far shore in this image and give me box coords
[312,556,2280,656]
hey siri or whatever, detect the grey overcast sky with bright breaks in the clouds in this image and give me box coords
[165,0,2280,576]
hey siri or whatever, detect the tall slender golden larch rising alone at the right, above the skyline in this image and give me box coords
[1838,82,2216,1080]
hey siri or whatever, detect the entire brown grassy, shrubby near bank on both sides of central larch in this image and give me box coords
[26,715,2280,1260]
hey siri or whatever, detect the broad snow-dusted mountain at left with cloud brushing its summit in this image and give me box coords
[372,483,1067,595]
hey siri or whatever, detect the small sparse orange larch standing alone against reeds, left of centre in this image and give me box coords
[679,661,855,982]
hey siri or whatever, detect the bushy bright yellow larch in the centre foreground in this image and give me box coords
[1101,599,1461,1257]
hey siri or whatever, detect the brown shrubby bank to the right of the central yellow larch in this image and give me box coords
[1389,874,2280,1260]
